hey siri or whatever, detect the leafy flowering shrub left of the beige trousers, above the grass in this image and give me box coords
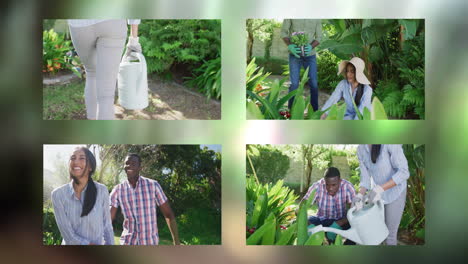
[42,29,81,77]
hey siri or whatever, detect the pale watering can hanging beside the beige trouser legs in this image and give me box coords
[118,52,148,110]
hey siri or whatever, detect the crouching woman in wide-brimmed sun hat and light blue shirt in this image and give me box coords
[320,57,372,120]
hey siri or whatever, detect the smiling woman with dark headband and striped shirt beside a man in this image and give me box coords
[52,147,114,245]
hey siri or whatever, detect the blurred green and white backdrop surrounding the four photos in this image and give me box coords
[0,0,468,263]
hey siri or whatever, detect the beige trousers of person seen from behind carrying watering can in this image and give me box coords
[70,19,127,120]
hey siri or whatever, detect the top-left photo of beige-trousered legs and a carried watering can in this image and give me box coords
[42,19,221,120]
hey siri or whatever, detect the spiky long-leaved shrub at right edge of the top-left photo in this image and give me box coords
[187,57,221,99]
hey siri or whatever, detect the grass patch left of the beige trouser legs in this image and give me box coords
[43,82,86,120]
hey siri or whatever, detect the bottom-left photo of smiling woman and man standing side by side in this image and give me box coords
[42,144,221,245]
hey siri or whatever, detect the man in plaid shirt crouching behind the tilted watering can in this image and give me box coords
[301,167,356,245]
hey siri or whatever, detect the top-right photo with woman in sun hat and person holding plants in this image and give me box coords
[246,19,425,120]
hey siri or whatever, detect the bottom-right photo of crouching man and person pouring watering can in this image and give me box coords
[246,144,426,246]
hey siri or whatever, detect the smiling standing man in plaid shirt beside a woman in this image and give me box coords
[110,154,180,245]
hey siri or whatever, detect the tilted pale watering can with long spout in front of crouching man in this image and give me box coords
[309,200,388,245]
